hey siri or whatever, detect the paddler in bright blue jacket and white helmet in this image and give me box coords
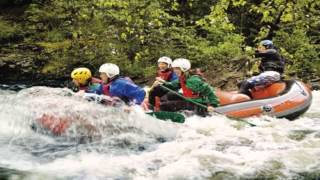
[99,63,146,105]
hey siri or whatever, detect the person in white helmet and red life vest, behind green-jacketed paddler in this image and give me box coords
[148,56,178,110]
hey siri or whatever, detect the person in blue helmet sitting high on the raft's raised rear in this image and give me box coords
[239,40,285,97]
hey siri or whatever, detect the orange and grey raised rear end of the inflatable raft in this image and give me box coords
[215,80,312,120]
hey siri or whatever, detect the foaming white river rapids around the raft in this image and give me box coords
[0,87,320,180]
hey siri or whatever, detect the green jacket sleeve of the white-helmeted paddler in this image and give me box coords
[186,76,219,107]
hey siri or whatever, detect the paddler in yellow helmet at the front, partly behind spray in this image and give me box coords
[71,67,103,95]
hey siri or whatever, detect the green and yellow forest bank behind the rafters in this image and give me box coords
[0,0,320,89]
